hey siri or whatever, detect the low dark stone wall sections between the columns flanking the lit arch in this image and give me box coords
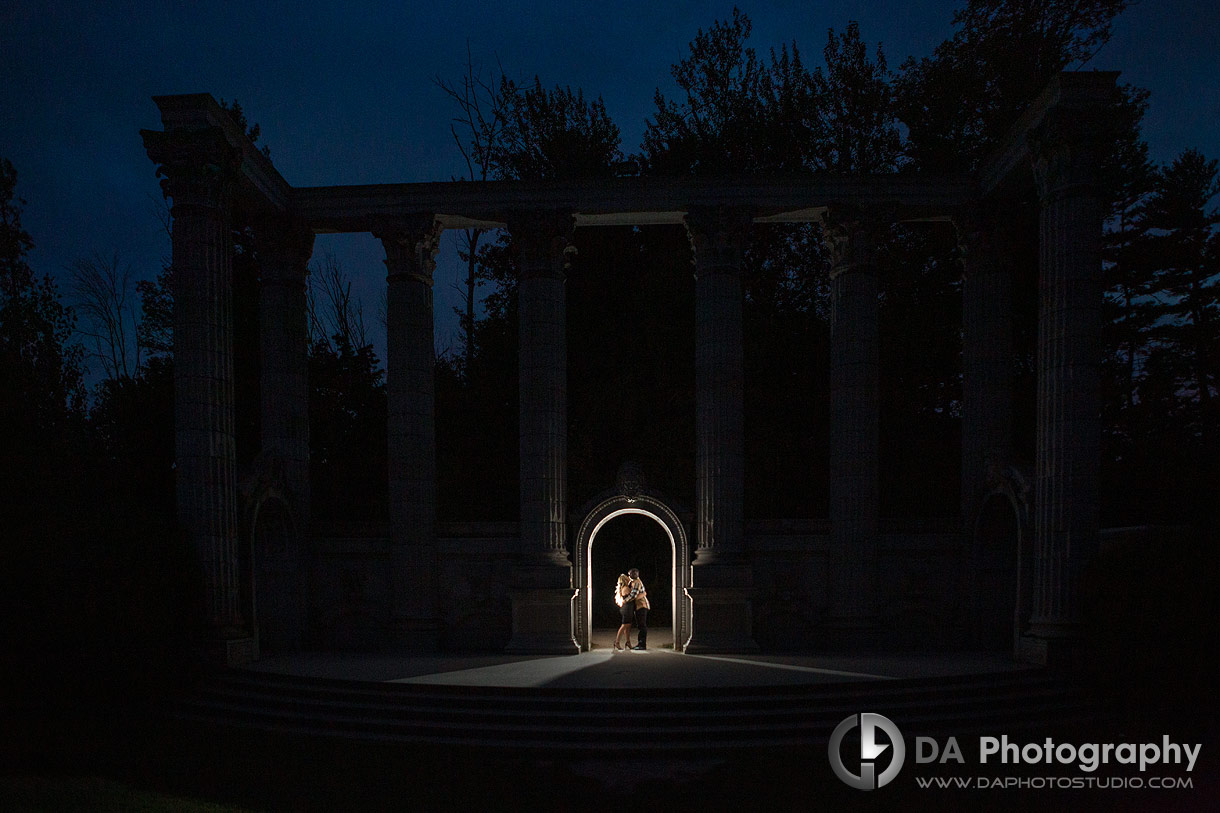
[310,520,965,652]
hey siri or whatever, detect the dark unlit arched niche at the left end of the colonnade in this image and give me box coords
[250,497,305,652]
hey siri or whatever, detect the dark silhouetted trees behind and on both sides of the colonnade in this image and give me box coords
[0,0,1220,703]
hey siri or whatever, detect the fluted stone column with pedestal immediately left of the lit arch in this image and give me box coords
[506,211,580,654]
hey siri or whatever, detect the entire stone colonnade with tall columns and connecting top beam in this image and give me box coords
[142,72,1116,663]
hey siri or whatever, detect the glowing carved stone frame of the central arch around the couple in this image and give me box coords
[572,494,691,652]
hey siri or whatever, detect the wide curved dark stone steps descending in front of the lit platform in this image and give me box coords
[173,670,1102,753]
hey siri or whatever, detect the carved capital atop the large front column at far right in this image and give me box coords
[1026,107,1107,204]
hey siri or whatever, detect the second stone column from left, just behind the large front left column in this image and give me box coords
[255,219,314,524]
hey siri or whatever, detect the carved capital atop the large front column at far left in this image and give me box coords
[140,128,242,210]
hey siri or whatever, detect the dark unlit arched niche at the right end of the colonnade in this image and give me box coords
[971,493,1030,651]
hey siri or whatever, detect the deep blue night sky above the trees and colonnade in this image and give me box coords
[0,0,1220,361]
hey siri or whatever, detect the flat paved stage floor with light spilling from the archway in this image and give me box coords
[242,631,1022,688]
